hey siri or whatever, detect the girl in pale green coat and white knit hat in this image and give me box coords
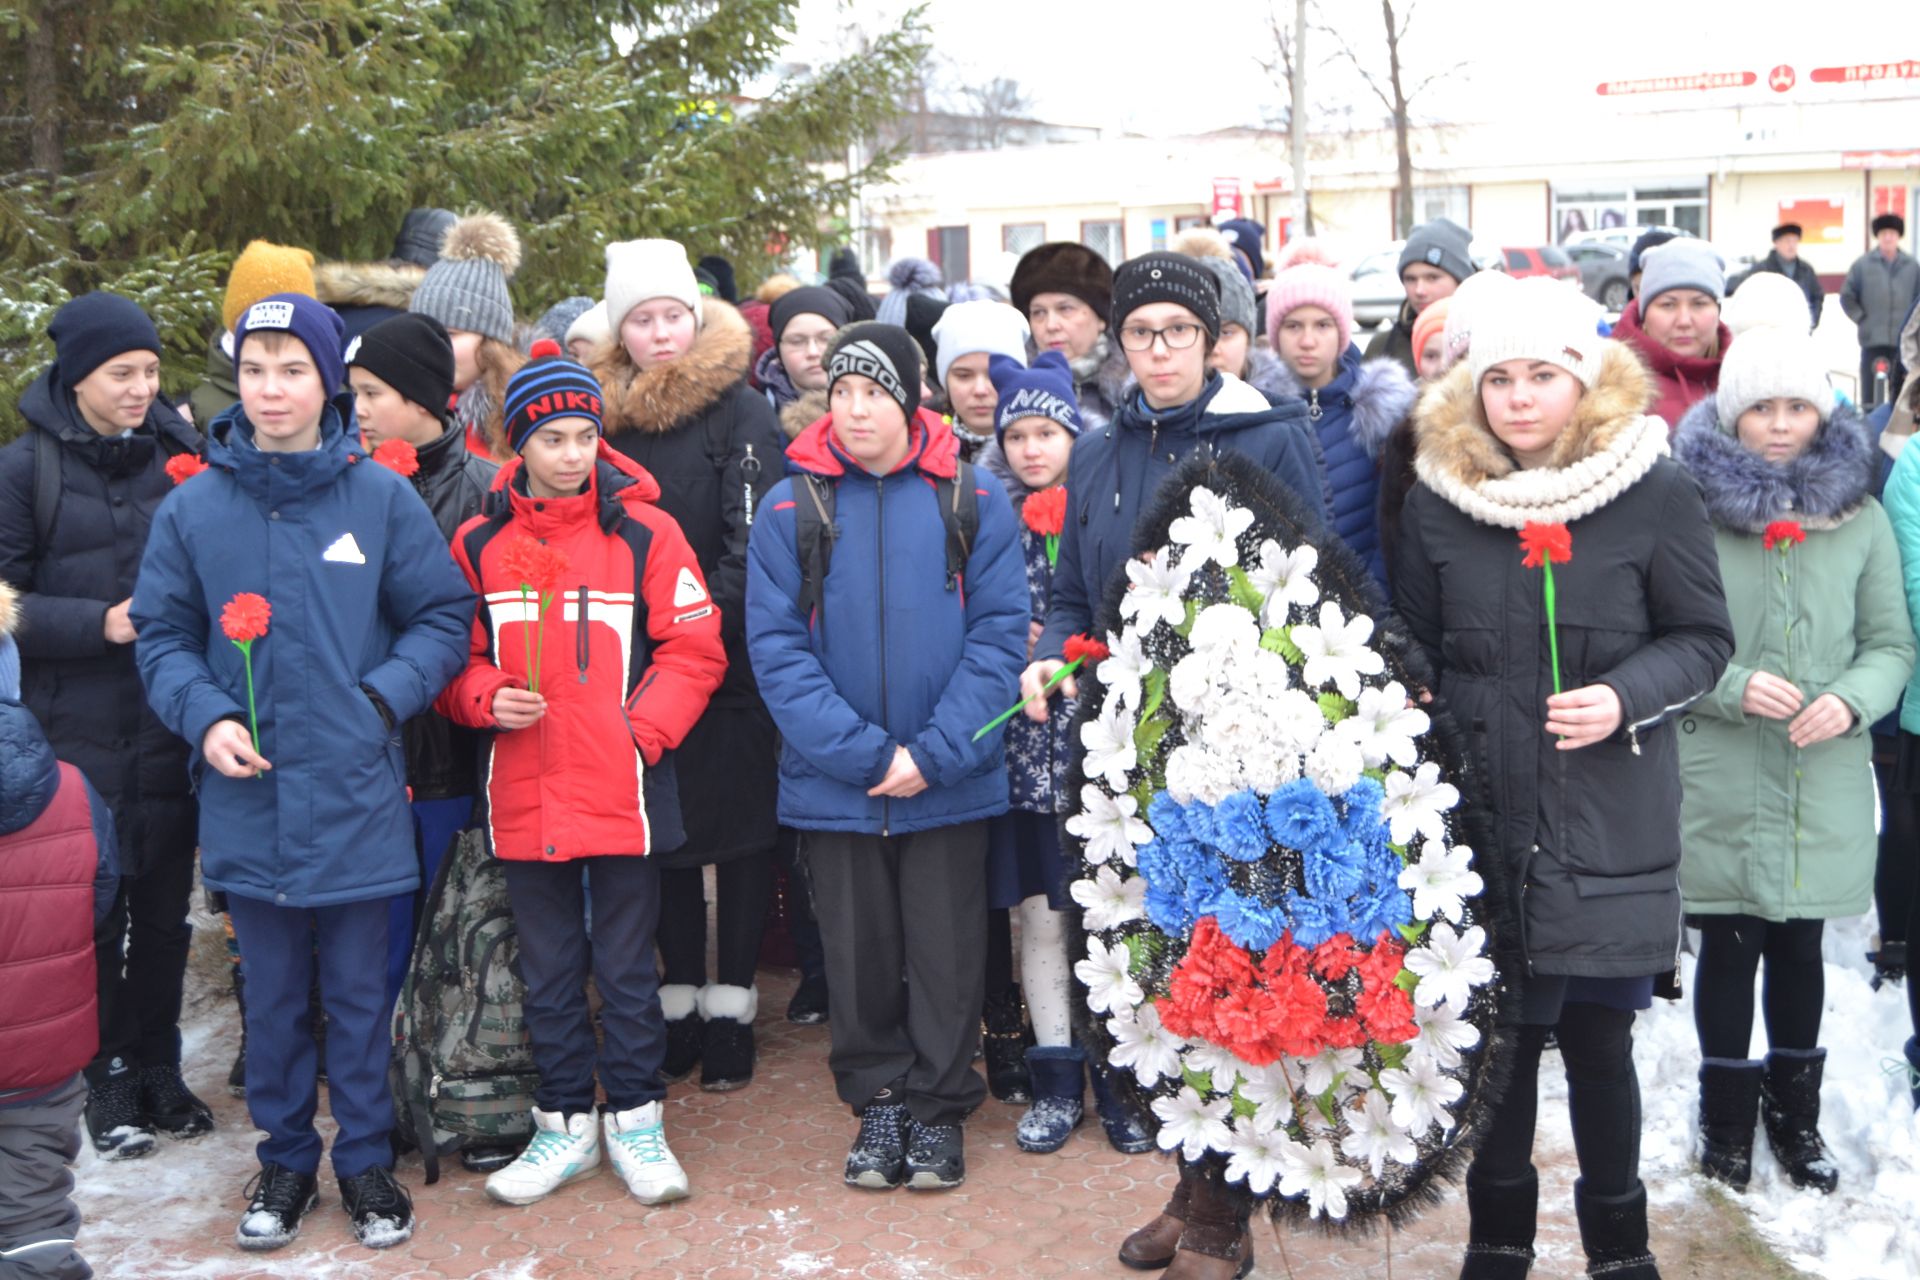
[1674,328,1914,1192]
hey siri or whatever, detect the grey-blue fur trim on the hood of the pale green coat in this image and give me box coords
[1674,397,1880,533]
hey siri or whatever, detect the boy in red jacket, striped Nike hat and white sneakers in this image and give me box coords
[438,342,726,1205]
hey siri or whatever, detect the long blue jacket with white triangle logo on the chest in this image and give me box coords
[132,405,474,906]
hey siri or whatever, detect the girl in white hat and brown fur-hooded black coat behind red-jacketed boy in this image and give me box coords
[591,240,785,1090]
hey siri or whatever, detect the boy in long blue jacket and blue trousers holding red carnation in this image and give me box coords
[132,294,474,1249]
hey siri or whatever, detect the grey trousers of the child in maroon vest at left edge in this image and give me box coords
[0,1075,94,1280]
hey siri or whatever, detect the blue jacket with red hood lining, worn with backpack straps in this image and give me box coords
[747,415,1031,835]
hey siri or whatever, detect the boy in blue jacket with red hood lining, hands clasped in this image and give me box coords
[741,322,1029,1190]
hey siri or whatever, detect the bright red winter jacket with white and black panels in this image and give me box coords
[436,441,726,862]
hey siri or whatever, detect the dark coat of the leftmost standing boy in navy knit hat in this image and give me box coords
[0,368,200,875]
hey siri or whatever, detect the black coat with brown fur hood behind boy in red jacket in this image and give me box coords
[593,297,787,869]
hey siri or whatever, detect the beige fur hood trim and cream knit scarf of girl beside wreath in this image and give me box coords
[1413,342,1668,530]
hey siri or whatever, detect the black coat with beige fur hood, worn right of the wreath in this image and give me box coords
[1394,342,1734,977]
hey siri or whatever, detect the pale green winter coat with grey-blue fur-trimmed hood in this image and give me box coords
[1674,397,1914,921]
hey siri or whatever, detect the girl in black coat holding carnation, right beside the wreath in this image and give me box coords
[1394,280,1734,1280]
